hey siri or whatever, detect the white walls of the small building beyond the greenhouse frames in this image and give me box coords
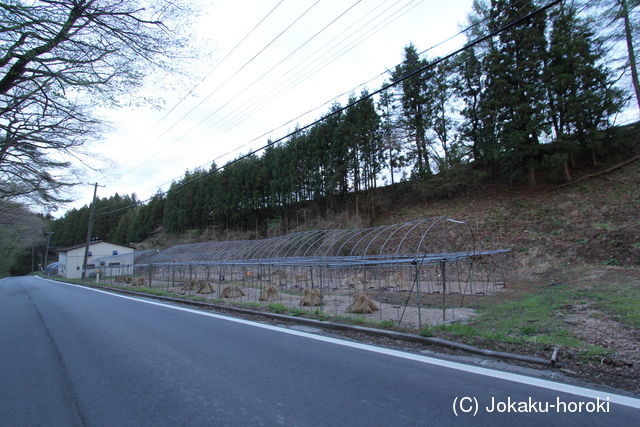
[58,242,133,279]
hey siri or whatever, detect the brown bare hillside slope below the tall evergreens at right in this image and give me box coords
[376,157,640,272]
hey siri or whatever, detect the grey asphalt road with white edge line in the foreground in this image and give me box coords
[0,277,640,427]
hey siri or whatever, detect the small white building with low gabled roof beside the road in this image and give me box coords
[58,240,133,279]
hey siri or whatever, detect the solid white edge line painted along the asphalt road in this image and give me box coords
[36,276,640,409]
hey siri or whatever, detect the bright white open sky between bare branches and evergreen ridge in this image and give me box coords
[62,0,480,216]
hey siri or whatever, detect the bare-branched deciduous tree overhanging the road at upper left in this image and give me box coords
[0,0,204,207]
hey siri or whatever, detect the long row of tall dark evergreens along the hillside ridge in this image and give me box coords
[52,0,632,251]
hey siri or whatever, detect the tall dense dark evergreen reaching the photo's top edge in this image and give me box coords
[483,0,547,185]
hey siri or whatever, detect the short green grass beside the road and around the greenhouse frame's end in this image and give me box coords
[58,270,640,360]
